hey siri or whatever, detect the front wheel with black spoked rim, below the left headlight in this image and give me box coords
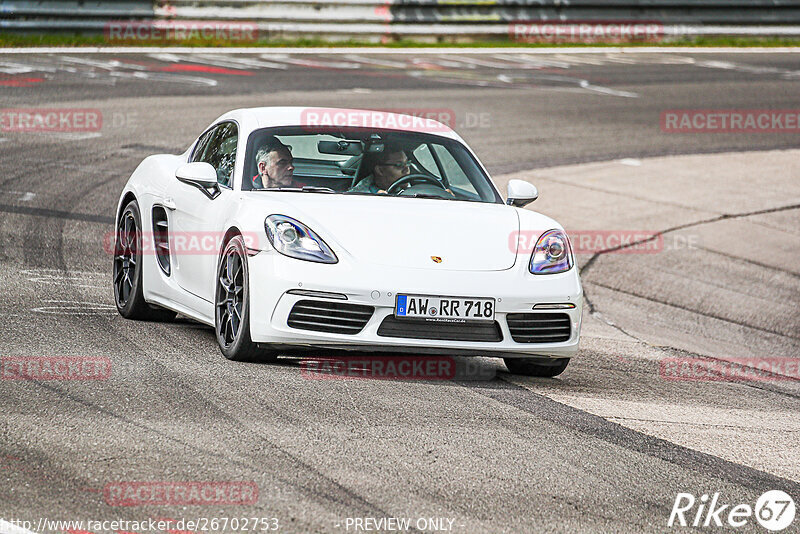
[214,235,276,362]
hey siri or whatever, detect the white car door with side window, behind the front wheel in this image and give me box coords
[167,121,238,302]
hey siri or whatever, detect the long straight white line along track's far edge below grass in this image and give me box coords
[0,46,800,56]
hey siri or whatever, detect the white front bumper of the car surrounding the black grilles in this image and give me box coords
[248,250,583,358]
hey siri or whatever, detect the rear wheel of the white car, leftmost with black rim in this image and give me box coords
[113,200,176,321]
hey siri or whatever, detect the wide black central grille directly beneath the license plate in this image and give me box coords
[378,315,503,341]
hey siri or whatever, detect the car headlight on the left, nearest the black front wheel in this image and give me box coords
[264,215,339,263]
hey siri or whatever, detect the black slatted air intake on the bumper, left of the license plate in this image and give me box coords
[286,300,375,334]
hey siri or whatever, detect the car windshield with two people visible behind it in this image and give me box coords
[242,127,502,203]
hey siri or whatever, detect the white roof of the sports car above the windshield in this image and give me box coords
[217,106,461,140]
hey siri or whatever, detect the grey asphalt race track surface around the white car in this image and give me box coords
[0,52,800,534]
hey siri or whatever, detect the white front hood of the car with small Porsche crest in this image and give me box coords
[256,192,519,271]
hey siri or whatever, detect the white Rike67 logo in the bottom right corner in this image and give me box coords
[667,490,796,532]
